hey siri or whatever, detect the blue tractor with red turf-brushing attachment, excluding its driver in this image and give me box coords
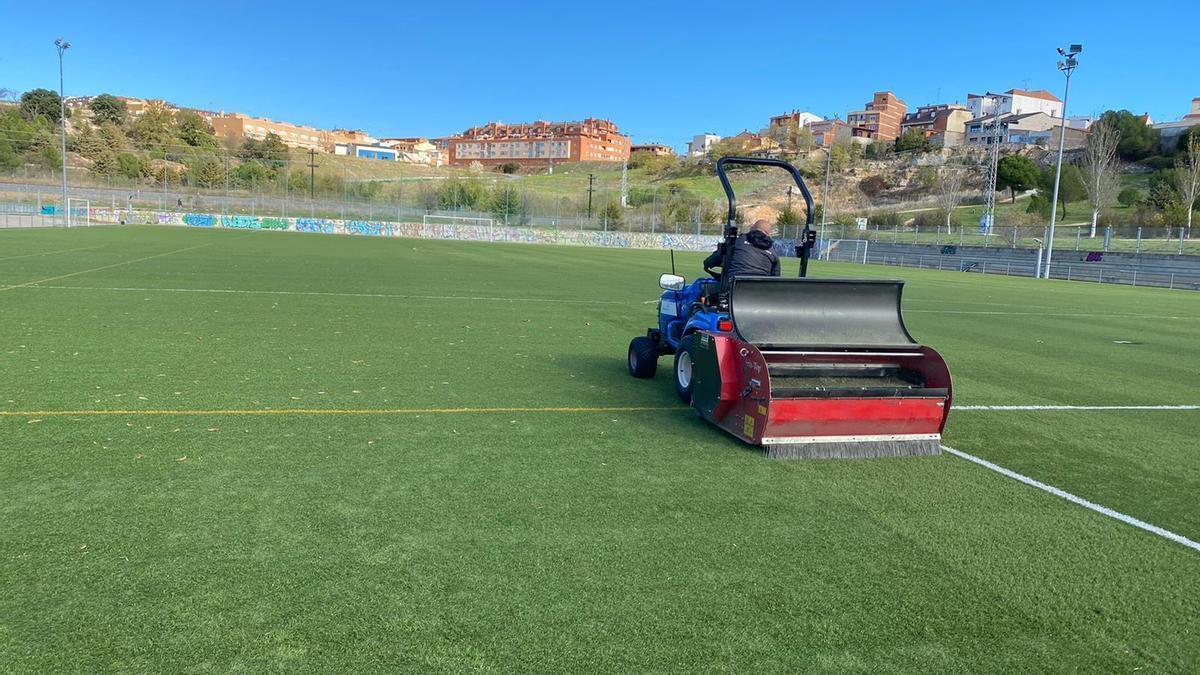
[629,157,952,459]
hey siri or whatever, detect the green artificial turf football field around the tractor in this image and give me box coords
[0,227,1200,673]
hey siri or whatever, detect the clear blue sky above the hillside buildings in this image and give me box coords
[0,0,1200,147]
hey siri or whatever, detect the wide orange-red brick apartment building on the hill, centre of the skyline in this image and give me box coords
[446,118,631,166]
